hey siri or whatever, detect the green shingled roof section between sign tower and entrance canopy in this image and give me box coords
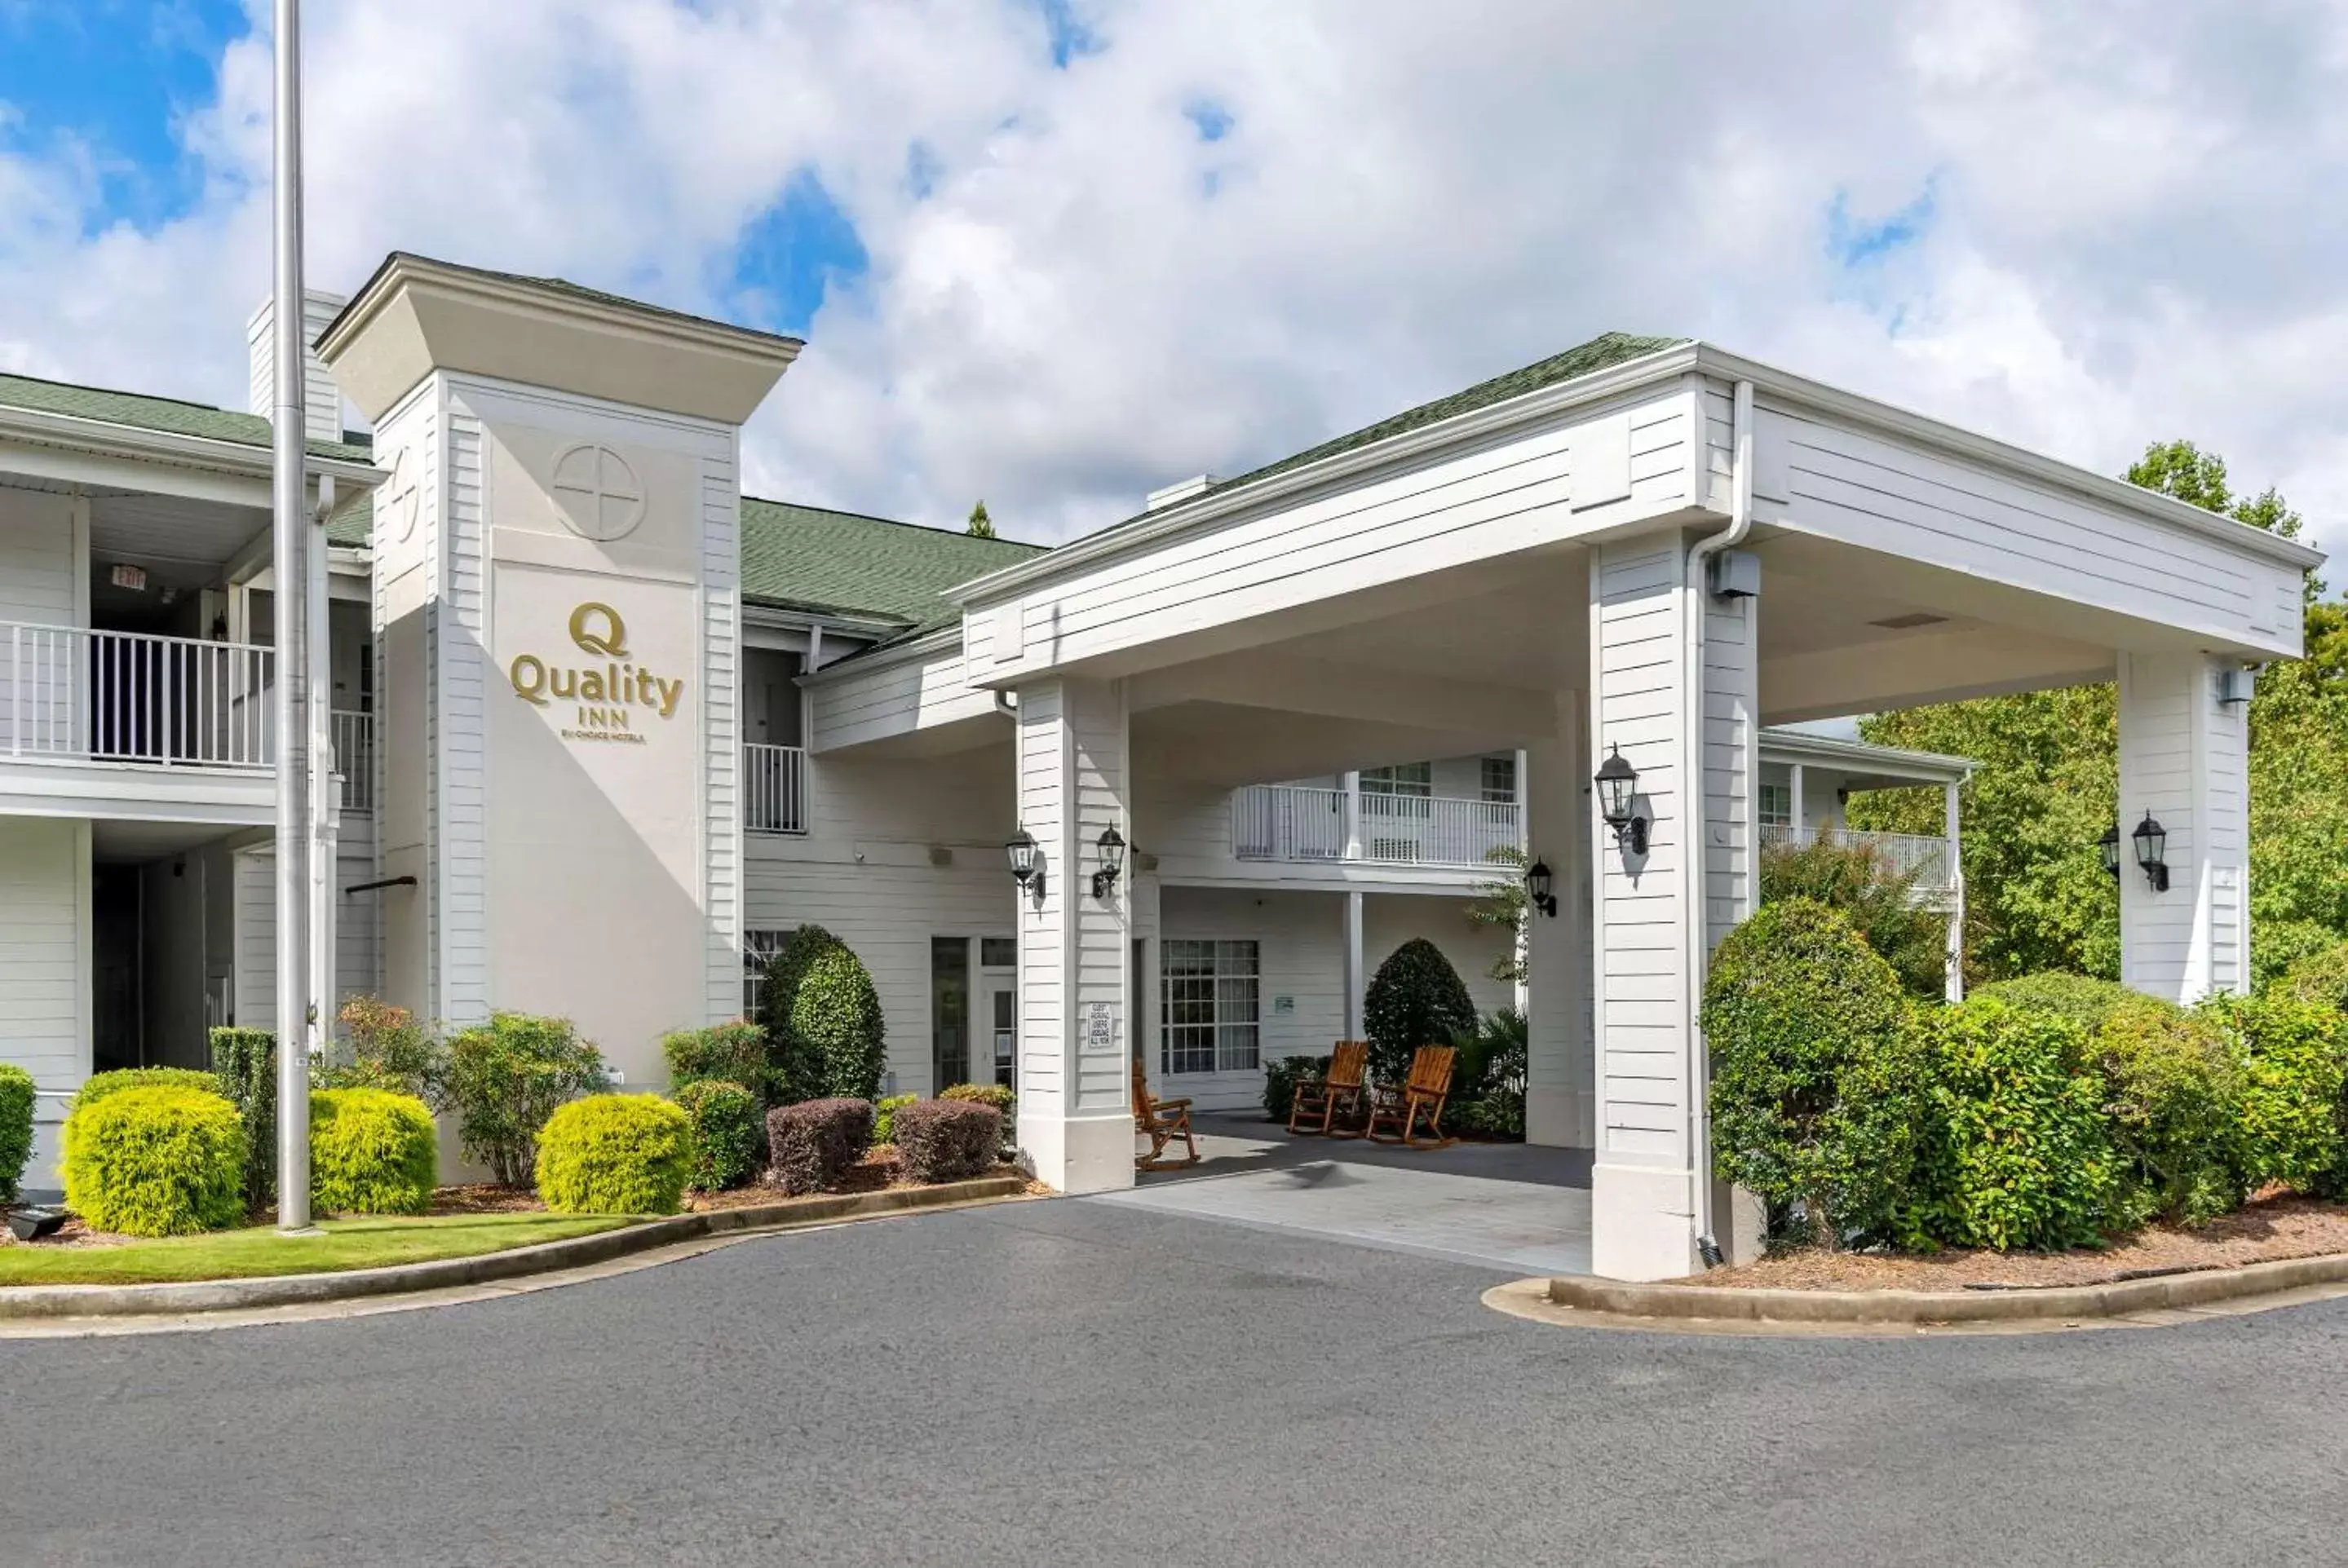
[742,495,1042,629]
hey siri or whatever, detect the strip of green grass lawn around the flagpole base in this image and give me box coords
[0,1213,631,1287]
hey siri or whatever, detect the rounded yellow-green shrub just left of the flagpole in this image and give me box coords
[66,1084,246,1237]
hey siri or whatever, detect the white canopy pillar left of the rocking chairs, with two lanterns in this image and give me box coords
[1015,678,1134,1192]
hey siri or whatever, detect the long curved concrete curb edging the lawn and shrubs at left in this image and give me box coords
[0,1176,1026,1322]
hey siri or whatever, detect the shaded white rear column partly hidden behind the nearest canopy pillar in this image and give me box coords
[1517,692,1597,1148]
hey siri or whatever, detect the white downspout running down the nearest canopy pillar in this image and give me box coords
[1678,380,1754,1239]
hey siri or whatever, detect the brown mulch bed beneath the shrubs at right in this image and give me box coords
[1688,1195,2348,1291]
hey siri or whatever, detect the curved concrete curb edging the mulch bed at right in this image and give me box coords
[1550,1253,2348,1324]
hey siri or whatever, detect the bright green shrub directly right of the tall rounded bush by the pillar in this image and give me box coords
[1902,997,2118,1251]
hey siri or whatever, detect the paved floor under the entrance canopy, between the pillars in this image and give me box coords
[1085,1115,1590,1274]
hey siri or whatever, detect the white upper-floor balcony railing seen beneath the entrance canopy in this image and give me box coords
[1231,784,1523,866]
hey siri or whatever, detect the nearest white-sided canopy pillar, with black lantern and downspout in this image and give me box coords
[1590,532,1758,1279]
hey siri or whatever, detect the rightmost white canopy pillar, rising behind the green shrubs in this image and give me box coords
[2120,655,2249,1002]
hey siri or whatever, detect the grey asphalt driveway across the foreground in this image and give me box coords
[0,1199,2348,1566]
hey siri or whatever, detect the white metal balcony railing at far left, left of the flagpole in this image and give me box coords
[0,622,277,770]
